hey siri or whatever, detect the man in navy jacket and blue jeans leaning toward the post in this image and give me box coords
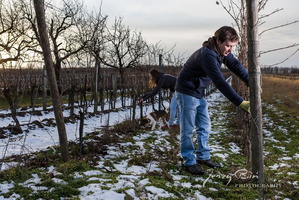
[175,26,249,175]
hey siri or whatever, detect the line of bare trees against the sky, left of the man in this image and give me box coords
[0,0,183,88]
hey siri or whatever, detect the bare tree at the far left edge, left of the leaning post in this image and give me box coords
[0,0,37,132]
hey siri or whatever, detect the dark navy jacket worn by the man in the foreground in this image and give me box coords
[175,47,248,106]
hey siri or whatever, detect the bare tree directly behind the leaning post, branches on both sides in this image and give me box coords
[20,0,91,91]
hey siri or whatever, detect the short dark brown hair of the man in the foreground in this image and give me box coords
[214,26,239,43]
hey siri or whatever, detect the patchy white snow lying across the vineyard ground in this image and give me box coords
[0,85,299,200]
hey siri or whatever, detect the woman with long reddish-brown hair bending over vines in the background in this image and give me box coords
[140,69,180,126]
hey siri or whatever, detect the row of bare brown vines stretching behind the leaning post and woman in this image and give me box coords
[0,66,180,134]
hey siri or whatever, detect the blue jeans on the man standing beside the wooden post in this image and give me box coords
[176,92,211,166]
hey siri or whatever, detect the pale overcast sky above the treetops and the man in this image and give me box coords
[84,0,299,67]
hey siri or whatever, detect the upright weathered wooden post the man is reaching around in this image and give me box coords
[247,0,264,188]
